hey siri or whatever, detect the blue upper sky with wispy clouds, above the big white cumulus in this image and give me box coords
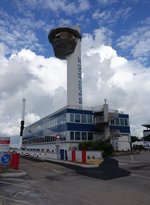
[0,0,150,65]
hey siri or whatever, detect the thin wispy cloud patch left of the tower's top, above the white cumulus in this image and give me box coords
[0,11,47,55]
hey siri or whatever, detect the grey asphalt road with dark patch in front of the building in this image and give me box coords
[0,152,150,205]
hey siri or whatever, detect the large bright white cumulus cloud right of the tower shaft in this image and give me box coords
[82,30,150,136]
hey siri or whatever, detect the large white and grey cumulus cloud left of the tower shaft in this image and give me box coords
[0,44,66,139]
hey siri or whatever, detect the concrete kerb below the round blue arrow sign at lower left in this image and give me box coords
[0,170,27,178]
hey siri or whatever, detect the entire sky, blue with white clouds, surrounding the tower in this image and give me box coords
[0,0,150,146]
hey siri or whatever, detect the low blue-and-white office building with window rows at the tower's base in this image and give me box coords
[23,104,130,152]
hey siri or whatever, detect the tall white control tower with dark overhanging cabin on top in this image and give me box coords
[48,27,82,108]
